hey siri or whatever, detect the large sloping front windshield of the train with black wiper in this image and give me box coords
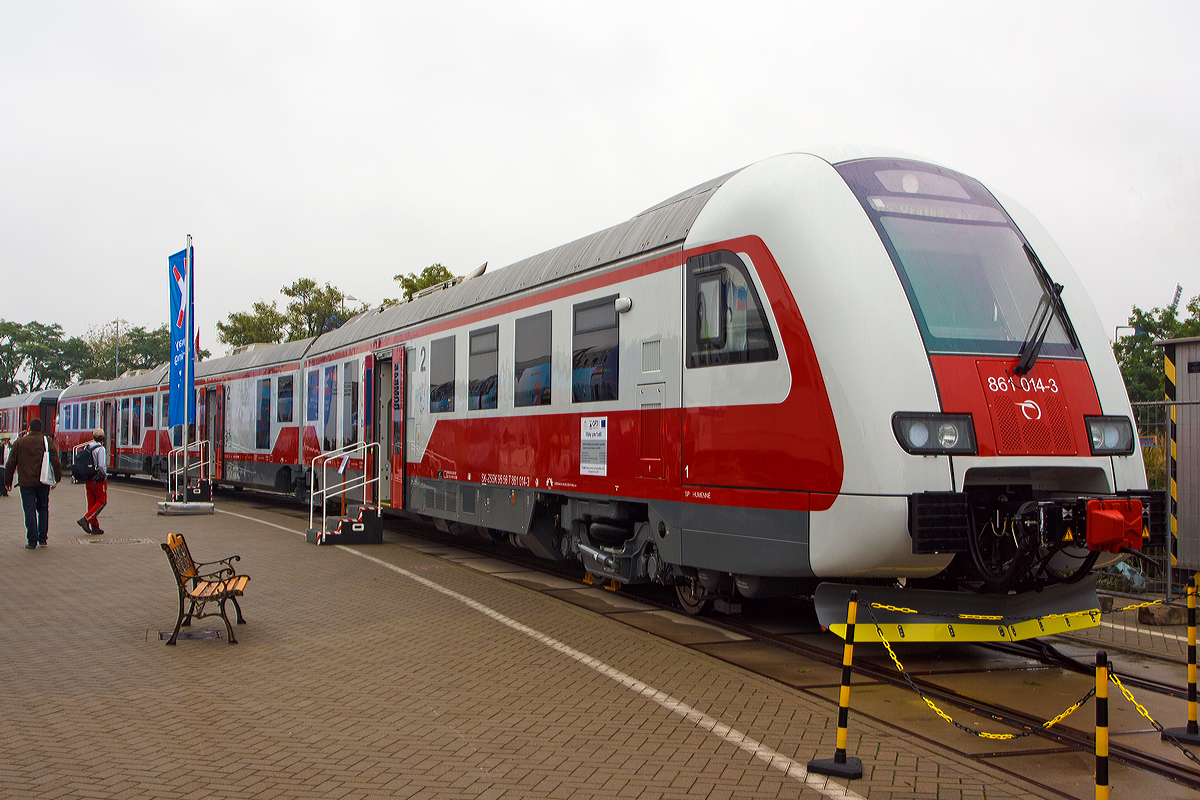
[836,158,1082,357]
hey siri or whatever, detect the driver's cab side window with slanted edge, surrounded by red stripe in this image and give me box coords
[685,249,779,367]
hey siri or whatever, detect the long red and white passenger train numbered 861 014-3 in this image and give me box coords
[39,148,1146,638]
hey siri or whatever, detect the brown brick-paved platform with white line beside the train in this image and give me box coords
[0,482,1152,800]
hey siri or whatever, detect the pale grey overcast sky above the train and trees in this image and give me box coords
[0,0,1200,354]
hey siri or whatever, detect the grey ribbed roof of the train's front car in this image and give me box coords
[308,170,740,355]
